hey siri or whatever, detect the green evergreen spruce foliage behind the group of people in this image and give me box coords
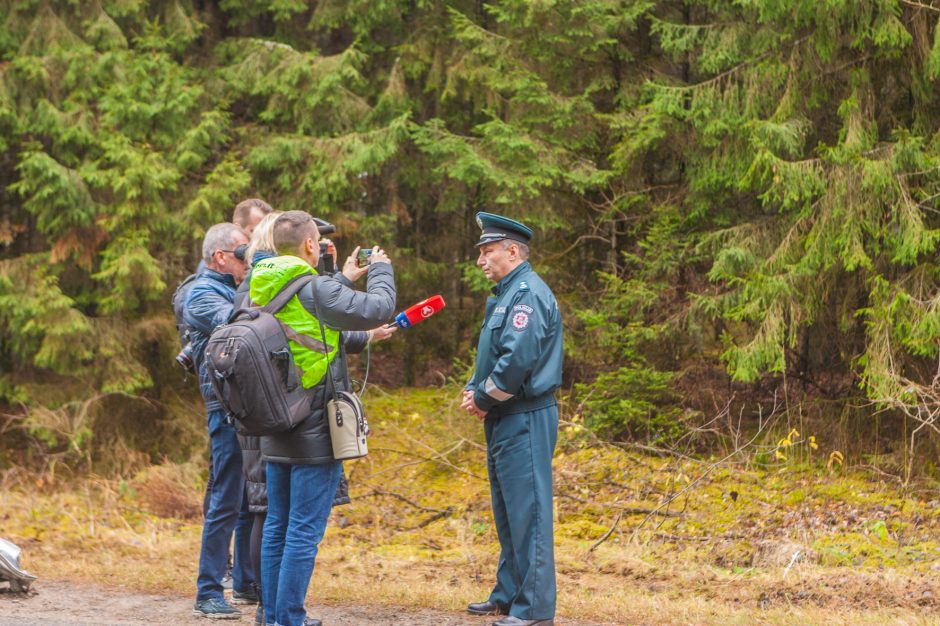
[0,0,940,458]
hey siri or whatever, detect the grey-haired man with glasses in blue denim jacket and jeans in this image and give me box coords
[184,223,257,619]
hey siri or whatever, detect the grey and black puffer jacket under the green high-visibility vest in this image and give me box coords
[261,263,395,465]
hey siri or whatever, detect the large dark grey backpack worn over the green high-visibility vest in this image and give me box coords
[205,274,326,436]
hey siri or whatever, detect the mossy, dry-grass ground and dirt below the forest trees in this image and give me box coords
[0,390,940,626]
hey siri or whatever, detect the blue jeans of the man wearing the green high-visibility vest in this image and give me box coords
[261,461,343,626]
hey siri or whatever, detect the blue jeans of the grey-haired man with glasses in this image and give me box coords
[196,411,255,600]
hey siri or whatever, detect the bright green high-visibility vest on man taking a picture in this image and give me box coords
[249,256,340,389]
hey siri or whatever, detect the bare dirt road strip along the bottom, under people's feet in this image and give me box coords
[0,580,606,626]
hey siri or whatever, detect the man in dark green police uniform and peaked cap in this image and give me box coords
[461,213,562,626]
